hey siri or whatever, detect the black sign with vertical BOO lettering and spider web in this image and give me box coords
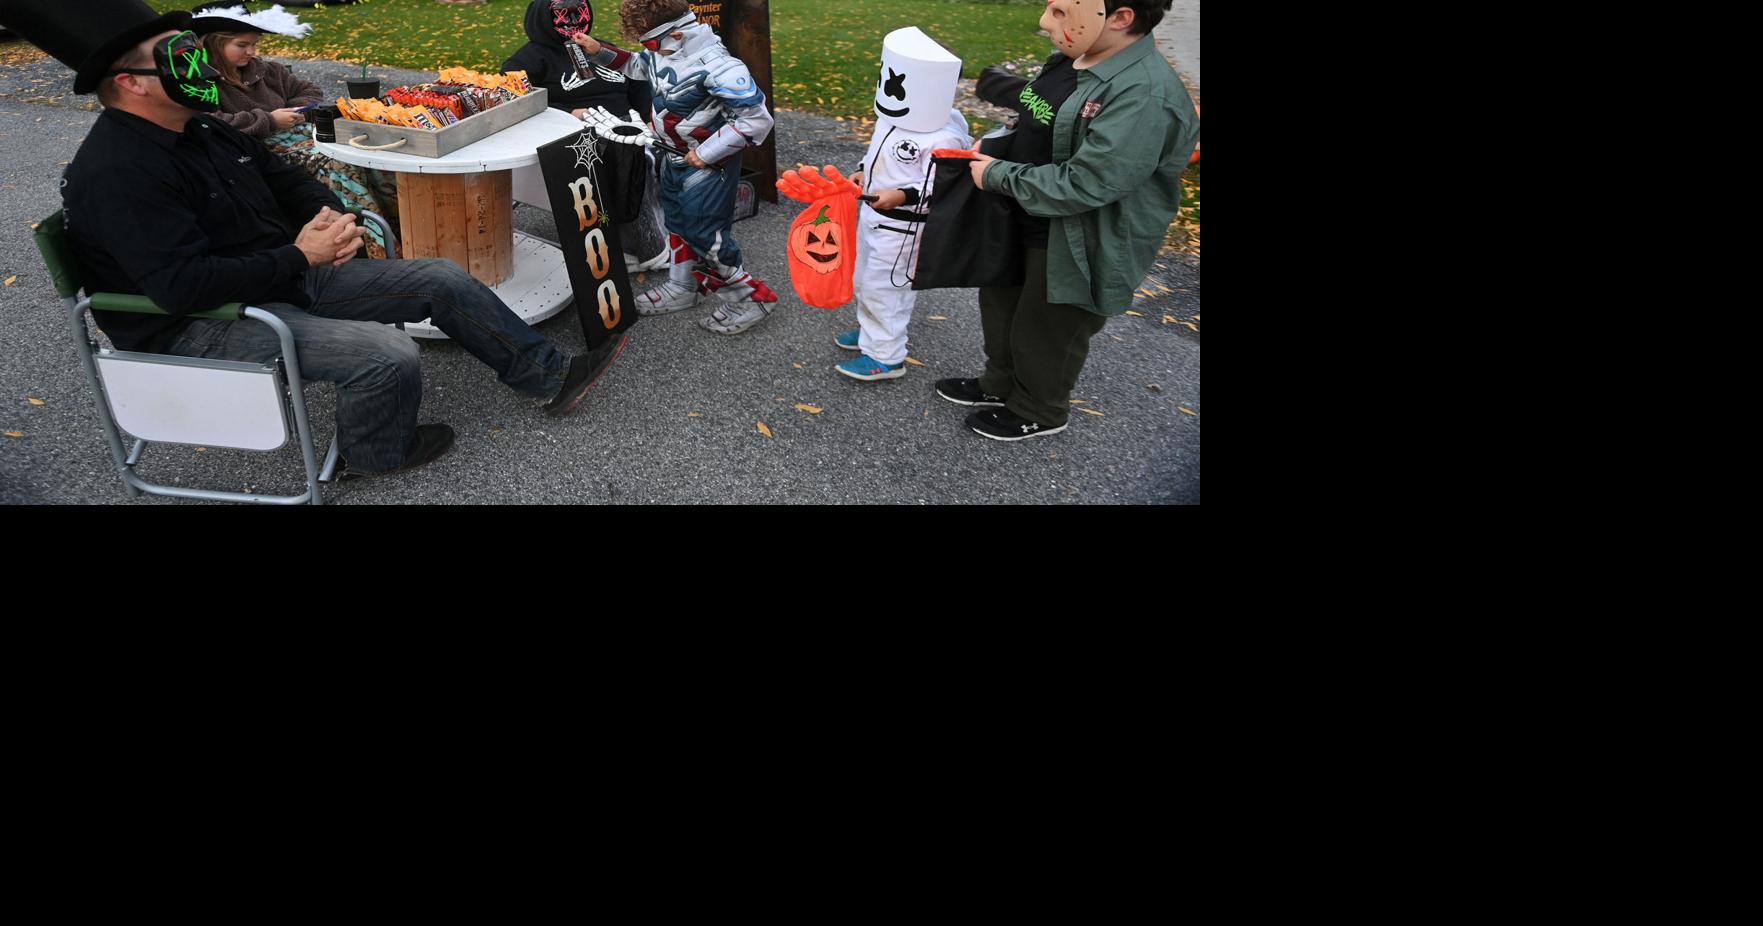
[538,132,647,349]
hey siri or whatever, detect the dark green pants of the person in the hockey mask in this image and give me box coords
[980,247,1107,427]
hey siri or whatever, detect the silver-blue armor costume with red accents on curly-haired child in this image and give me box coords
[596,12,777,335]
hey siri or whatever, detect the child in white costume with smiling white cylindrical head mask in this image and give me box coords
[832,26,971,381]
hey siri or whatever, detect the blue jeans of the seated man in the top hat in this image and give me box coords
[166,259,569,473]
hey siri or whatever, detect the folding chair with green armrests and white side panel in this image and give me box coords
[32,210,397,504]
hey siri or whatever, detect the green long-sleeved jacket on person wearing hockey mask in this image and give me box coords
[980,35,1201,316]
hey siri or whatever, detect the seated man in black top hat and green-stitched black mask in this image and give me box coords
[0,0,624,474]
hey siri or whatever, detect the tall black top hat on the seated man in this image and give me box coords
[0,0,190,93]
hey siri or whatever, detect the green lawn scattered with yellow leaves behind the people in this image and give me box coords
[148,0,1051,118]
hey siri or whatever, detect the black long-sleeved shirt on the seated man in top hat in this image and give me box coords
[62,109,342,351]
